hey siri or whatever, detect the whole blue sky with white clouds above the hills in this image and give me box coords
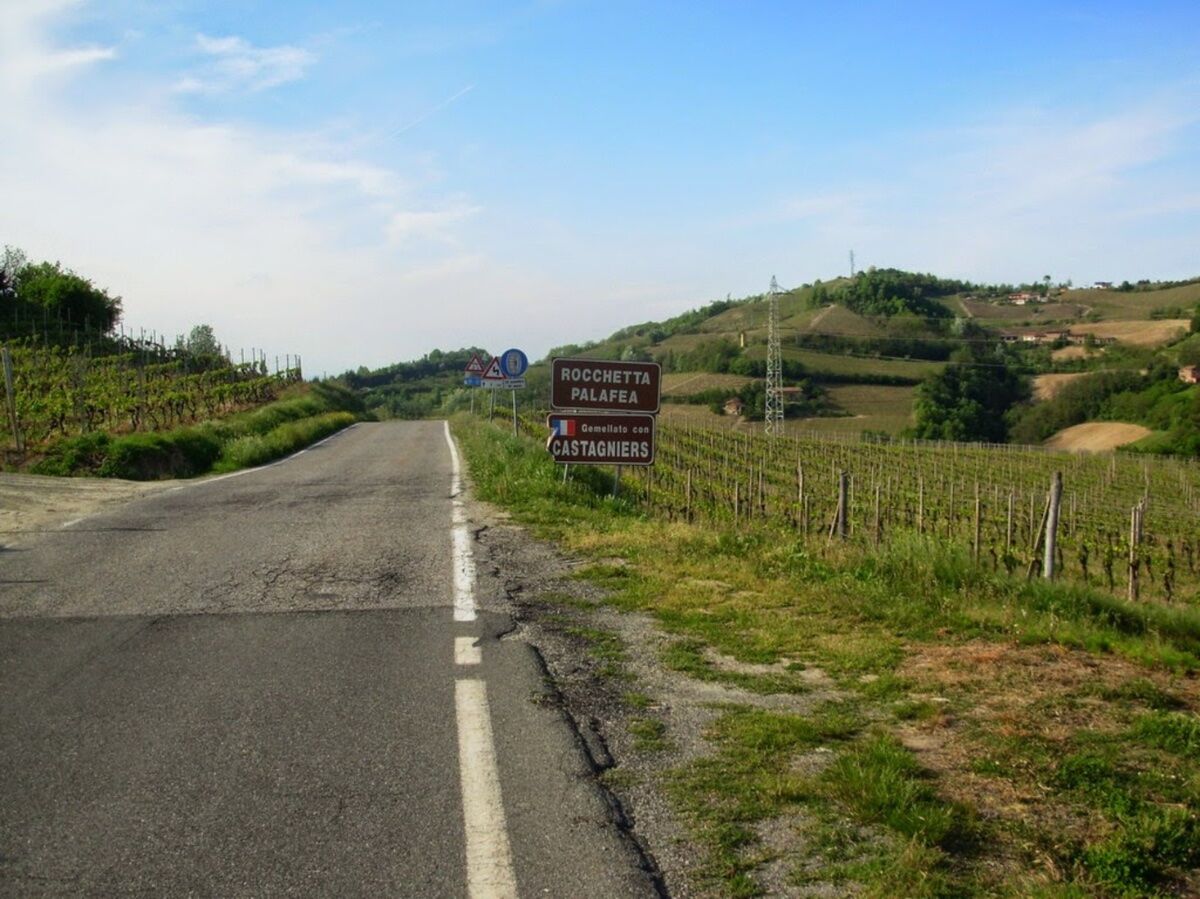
[0,0,1200,376]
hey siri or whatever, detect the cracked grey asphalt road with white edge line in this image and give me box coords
[0,422,655,898]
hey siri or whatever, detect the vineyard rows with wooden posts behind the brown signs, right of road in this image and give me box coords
[511,415,1200,601]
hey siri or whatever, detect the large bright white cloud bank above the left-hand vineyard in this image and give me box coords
[0,7,520,373]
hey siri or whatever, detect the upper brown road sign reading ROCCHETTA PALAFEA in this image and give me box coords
[550,359,662,413]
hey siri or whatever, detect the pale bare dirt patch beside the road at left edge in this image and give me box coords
[0,472,172,543]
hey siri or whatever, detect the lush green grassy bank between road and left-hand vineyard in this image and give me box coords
[31,384,362,480]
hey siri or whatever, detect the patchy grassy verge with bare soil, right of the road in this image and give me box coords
[455,418,1200,895]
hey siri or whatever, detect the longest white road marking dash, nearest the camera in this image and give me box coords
[454,678,517,899]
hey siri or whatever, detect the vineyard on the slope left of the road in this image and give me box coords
[0,343,301,448]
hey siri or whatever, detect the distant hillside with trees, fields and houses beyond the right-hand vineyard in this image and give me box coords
[343,262,1200,453]
